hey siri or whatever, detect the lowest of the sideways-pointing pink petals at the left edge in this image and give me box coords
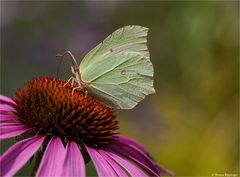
[0,123,30,141]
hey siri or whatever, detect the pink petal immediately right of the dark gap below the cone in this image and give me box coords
[85,146,117,177]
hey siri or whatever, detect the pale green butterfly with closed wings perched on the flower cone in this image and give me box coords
[58,25,155,109]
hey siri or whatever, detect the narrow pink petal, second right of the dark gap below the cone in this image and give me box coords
[98,150,128,177]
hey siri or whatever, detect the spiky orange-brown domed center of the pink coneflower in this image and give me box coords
[14,78,118,146]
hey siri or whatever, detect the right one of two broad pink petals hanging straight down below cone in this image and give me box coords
[61,142,86,177]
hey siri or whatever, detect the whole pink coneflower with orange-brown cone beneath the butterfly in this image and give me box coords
[0,78,173,177]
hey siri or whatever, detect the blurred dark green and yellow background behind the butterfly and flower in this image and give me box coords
[1,1,239,176]
